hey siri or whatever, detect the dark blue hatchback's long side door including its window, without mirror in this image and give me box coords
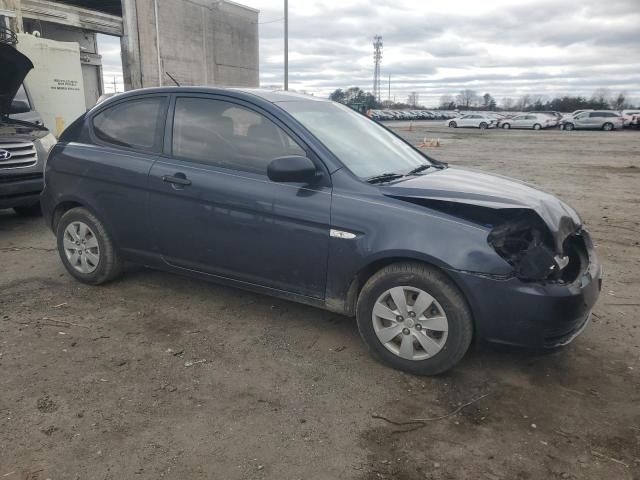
[148,96,331,298]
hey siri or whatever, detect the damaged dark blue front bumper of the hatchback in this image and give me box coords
[450,232,602,348]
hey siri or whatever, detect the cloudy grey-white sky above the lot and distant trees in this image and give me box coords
[96,0,640,106]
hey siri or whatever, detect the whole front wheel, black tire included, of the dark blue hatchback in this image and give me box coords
[356,263,473,375]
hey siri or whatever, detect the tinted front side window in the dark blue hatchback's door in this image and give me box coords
[173,97,306,174]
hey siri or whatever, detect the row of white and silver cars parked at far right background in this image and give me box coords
[446,110,640,131]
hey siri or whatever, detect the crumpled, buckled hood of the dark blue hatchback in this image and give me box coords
[380,167,581,252]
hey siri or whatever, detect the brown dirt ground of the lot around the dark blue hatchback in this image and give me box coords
[0,123,640,480]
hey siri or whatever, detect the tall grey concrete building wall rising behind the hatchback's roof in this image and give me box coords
[122,0,258,90]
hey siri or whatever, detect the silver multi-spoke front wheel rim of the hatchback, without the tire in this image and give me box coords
[371,286,449,361]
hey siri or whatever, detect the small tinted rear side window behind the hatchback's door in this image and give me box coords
[93,97,167,150]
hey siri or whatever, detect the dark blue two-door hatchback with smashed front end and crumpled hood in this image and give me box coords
[42,87,601,375]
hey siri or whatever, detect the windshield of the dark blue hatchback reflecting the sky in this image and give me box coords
[278,101,431,178]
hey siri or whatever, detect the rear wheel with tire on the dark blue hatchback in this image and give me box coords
[56,207,122,285]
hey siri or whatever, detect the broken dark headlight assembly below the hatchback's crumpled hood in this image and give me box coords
[487,212,570,281]
